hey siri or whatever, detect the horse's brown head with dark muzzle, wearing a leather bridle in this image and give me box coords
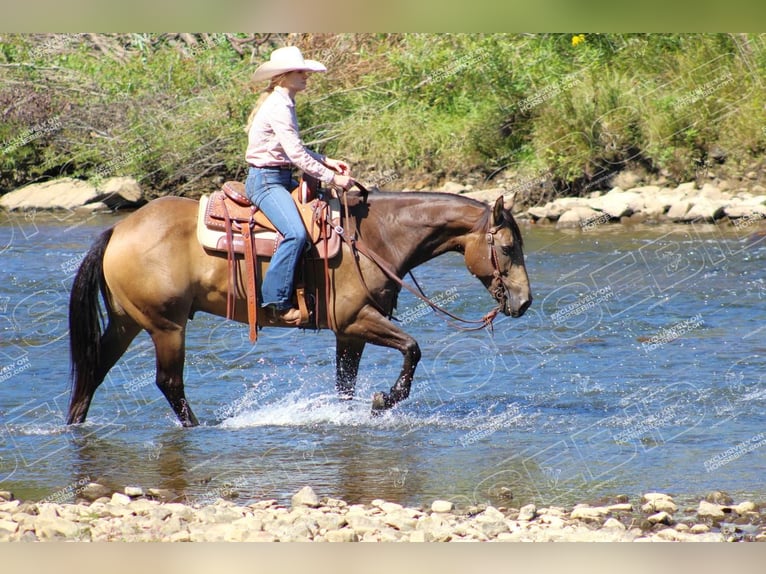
[465,196,532,317]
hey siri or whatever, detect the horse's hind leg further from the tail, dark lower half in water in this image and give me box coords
[151,327,199,427]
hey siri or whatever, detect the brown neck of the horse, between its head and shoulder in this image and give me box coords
[368,193,487,274]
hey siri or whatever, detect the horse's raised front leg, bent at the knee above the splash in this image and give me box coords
[344,306,420,414]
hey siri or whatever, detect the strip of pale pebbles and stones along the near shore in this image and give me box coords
[0,485,766,542]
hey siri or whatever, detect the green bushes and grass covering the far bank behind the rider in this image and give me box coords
[0,32,766,202]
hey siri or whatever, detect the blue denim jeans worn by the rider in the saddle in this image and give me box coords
[245,167,308,311]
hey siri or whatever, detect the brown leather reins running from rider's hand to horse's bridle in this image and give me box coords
[335,187,503,331]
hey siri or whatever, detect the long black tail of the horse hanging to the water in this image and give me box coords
[67,228,114,424]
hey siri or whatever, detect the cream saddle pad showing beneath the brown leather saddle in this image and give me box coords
[197,198,341,259]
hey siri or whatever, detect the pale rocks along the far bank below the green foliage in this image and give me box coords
[0,172,766,235]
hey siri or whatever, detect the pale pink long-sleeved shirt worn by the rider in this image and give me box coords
[245,86,335,183]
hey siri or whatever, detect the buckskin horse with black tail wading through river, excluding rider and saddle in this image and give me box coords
[67,187,532,427]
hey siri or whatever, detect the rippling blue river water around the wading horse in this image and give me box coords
[0,206,766,507]
